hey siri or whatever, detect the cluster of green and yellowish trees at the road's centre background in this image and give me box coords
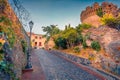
[42,24,92,49]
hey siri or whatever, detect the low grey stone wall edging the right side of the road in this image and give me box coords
[50,50,120,80]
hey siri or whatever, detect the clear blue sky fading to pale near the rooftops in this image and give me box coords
[9,0,120,34]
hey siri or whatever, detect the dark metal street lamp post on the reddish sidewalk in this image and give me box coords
[25,21,34,70]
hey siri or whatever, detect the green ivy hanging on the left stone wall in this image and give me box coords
[0,16,18,80]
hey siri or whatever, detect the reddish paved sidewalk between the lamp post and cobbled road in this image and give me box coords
[21,51,45,80]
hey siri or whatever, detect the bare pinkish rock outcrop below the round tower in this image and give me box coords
[88,26,120,75]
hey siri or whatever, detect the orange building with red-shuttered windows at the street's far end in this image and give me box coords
[28,33,46,49]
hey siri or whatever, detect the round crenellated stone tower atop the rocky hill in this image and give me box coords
[80,2,120,27]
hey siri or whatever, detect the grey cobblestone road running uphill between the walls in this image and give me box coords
[35,49,102,80]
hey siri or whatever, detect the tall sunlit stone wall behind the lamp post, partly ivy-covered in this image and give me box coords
[0,0,26,80]
